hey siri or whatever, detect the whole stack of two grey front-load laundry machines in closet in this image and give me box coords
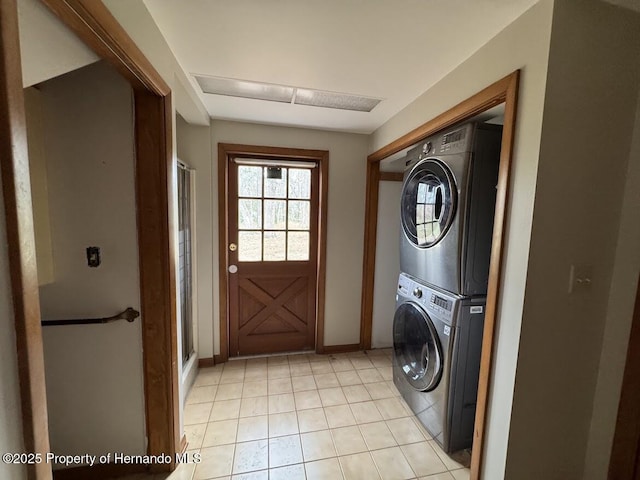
[393,123,502,453]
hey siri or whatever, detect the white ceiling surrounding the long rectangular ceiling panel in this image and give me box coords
[144,0,537,133]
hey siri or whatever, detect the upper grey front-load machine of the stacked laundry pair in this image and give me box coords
[400,123,502,295]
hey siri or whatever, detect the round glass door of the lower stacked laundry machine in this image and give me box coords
[393,303,443,392]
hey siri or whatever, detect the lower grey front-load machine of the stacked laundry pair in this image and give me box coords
[393,274,485,453]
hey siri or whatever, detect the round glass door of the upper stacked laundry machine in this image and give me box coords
[401,160,457,248]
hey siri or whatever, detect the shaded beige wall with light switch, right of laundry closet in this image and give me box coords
[507,0,640,480]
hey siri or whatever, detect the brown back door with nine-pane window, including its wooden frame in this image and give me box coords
[218,144,329,361]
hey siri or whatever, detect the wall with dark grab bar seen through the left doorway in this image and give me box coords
[34,64,146,464]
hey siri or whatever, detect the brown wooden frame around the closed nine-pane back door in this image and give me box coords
[219,143,329,363]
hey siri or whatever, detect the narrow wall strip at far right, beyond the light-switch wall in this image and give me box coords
[584,73,640,480]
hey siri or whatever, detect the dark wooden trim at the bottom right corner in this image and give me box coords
[607,279,640,480]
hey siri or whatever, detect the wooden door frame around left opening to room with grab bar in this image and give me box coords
[0,0,181,480]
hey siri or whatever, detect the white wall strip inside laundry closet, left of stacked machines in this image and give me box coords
[371,181,402,348]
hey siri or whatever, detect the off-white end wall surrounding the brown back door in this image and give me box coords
[211,120,367,353]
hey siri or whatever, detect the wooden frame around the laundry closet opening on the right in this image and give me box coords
[360,70,520,480]
